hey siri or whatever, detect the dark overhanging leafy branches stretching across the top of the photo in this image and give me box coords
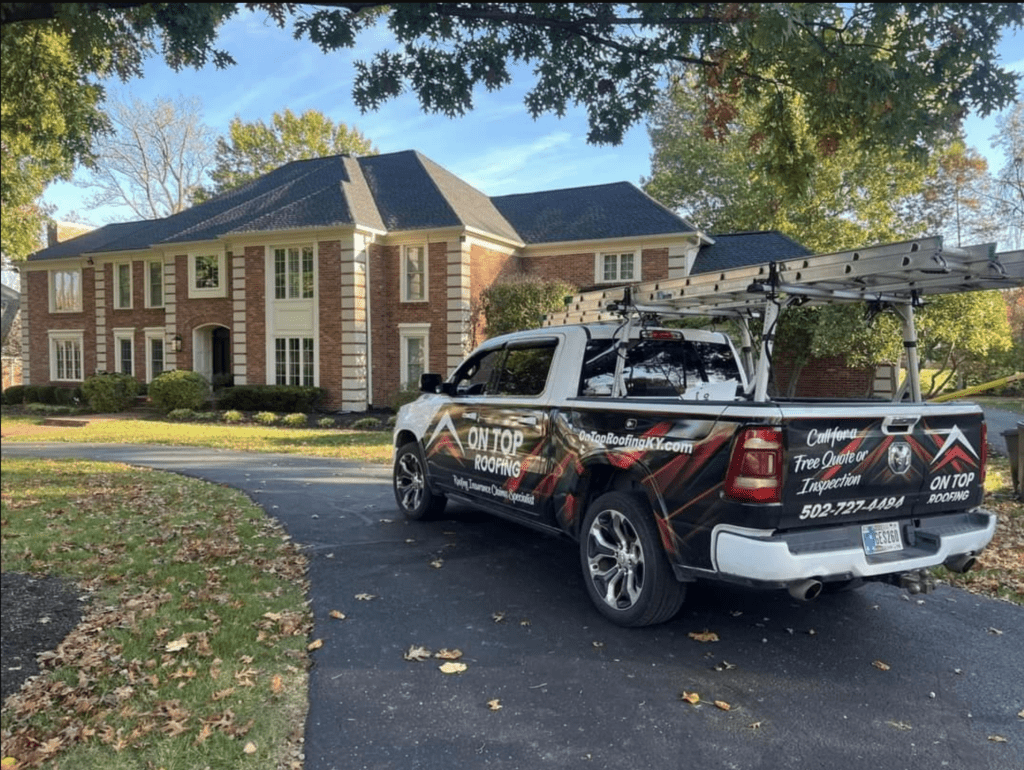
[0,3,1024,195]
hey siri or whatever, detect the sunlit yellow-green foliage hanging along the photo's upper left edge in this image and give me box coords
[0,26,108,259]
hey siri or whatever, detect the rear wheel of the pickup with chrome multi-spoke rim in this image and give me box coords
[580,491,686,627]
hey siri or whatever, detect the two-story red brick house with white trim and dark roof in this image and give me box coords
[23,151,806,411]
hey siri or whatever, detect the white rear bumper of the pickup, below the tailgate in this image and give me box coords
[712,508,995,585]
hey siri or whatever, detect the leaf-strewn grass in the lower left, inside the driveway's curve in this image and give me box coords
[0,458,311,770]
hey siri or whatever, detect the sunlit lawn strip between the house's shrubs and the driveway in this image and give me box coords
[3,411,391,465]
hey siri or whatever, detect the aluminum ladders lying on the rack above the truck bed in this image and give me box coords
[544,237,1024,327]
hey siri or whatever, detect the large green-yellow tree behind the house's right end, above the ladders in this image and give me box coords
[644,77,927,252]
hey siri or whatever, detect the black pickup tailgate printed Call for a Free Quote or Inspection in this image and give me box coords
[779,403,983,528]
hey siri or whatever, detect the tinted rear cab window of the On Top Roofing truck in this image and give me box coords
[580,340,740,398]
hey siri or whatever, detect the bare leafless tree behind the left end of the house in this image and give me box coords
[83,96,216,219]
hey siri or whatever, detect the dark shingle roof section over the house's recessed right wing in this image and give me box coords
[490,182,693,244]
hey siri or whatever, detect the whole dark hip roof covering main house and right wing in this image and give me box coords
[30,151,693,260]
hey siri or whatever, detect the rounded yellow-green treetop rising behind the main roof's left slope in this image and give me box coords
[205,110,377,197]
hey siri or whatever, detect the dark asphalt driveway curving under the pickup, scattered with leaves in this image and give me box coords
[3,444,1024,770]
